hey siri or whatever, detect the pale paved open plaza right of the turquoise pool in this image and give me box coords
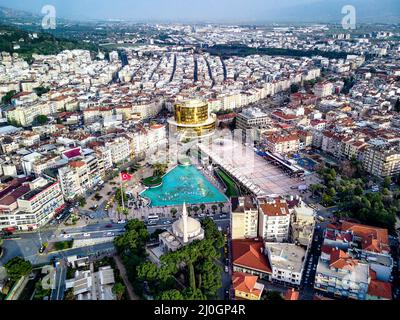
[199,140,299,196]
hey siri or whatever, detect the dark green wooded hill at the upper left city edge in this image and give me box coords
[0,25,98,62]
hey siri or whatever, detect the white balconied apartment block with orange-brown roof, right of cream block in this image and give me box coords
[258,198,291,242]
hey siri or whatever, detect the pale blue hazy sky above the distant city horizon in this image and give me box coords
[0,0,400,23]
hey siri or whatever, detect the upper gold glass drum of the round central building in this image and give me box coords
[175,101,209,125]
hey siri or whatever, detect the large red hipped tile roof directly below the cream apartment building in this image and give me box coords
[232,240,272,273]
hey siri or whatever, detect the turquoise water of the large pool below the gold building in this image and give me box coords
[142,166,227,207]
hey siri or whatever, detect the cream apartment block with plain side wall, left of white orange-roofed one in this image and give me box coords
[231,197,258,239]
